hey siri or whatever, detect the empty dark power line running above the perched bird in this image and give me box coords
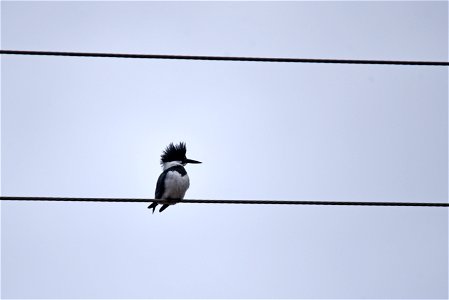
[0,50,449,66]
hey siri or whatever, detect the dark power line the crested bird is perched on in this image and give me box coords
[0,197,449,207]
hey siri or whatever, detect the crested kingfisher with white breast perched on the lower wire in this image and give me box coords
[148,142,201,213]
